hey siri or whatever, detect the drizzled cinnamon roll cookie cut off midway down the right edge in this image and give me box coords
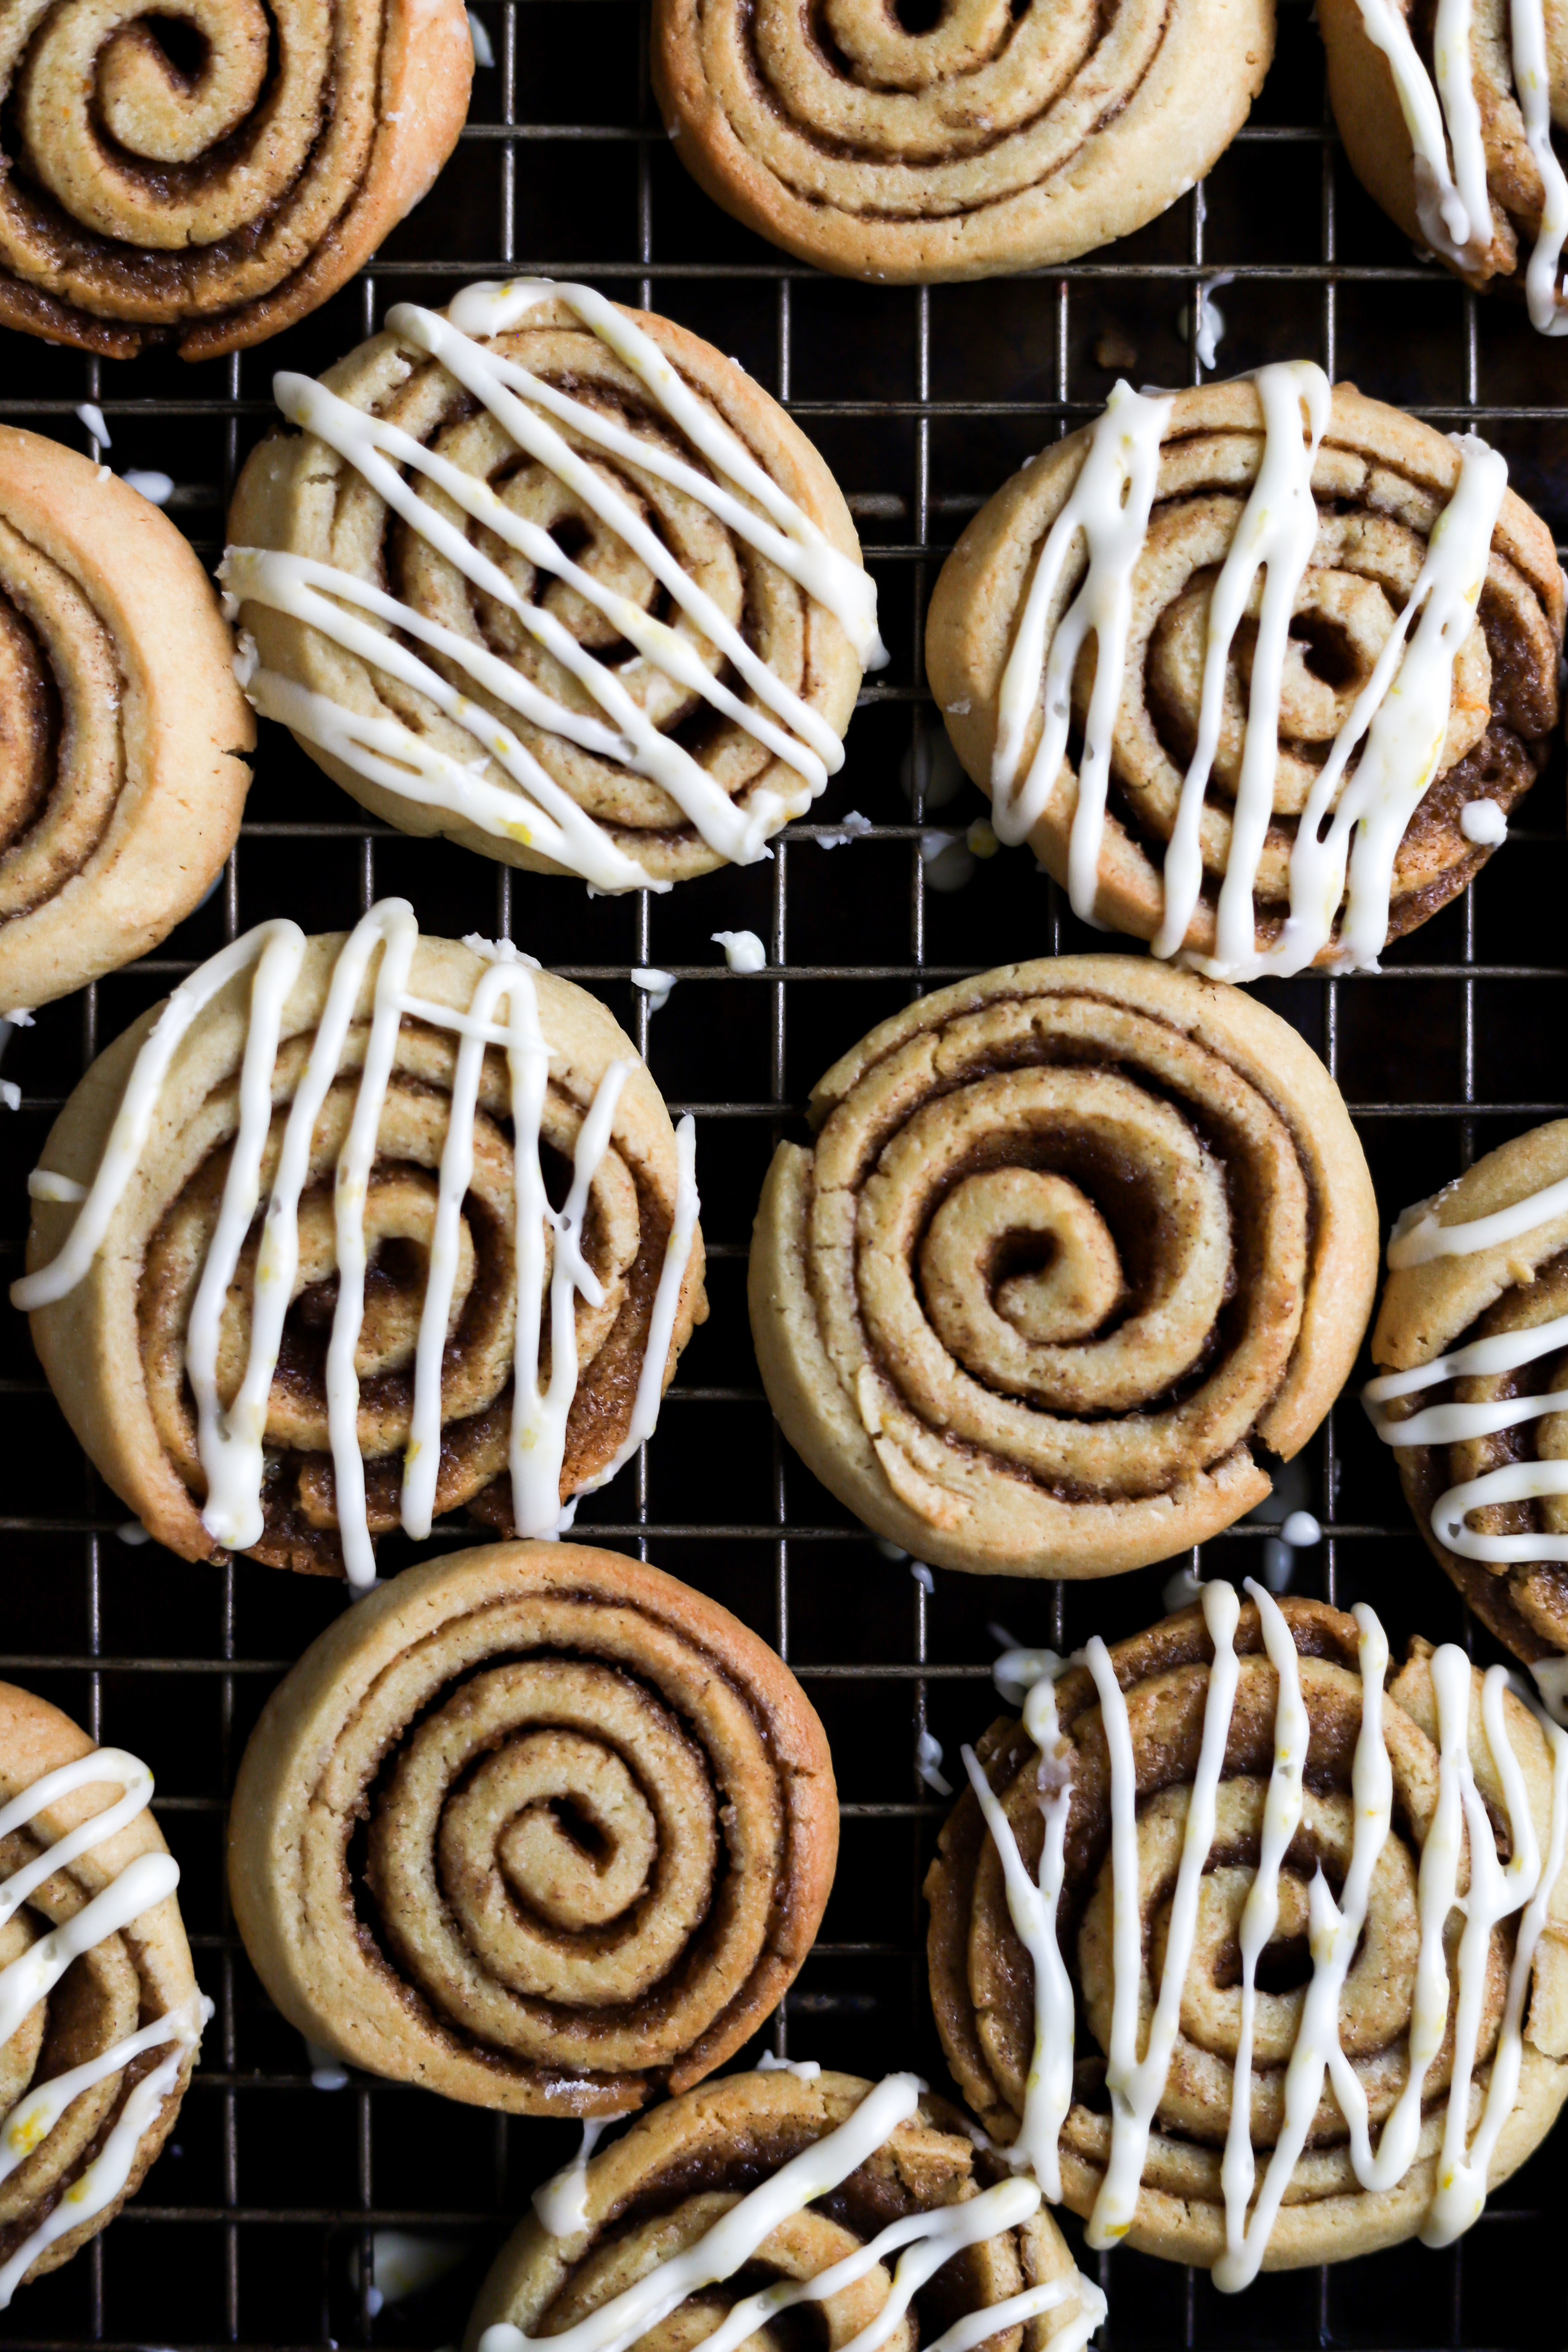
[1366,1120,1568,1712]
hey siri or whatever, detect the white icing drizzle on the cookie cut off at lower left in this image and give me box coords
[0,1748,212,2312]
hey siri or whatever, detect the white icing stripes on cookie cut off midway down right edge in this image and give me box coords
[1361,1147,1568,1567]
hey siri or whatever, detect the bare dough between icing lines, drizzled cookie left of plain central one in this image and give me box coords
[28,934,708,1576]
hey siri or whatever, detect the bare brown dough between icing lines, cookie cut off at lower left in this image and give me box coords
[0,1682,197,2279]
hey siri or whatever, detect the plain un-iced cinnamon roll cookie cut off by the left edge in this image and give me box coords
[0,430,256,1009]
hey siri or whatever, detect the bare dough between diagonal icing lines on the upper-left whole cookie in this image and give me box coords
[228,301,860,882]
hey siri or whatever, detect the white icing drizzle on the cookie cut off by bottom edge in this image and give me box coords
[479,2075,1105,2352]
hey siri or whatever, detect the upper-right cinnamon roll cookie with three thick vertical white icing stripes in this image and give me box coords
[926,362,1563,981]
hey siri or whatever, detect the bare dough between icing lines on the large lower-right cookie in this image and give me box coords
[926,1599,1568,2270]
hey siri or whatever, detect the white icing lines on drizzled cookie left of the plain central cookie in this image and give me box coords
[12,899,700,1599]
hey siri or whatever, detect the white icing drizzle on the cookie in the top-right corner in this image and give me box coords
[1356,0,1568,334]
